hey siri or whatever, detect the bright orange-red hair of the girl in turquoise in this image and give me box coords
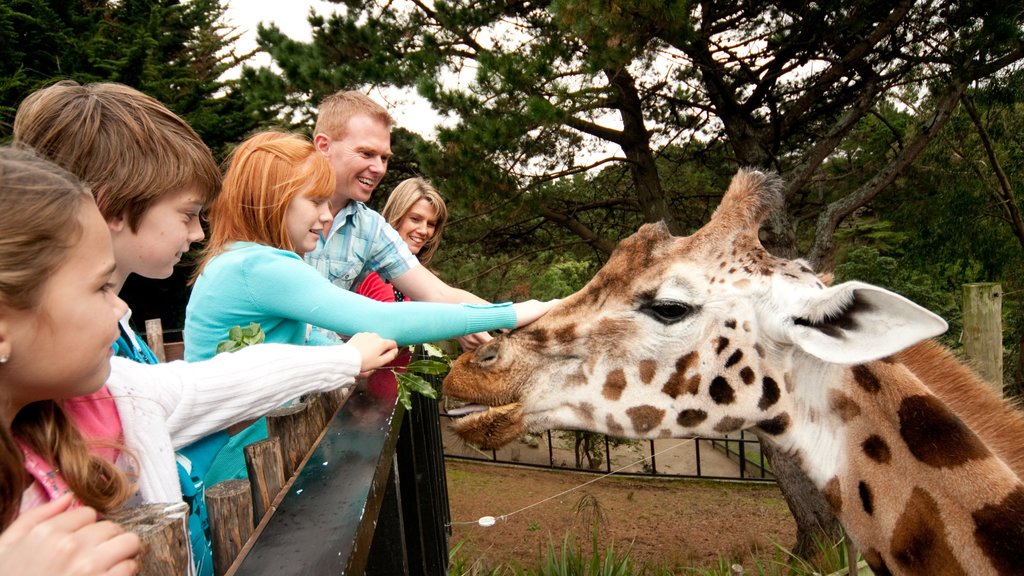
[196,131,335,276]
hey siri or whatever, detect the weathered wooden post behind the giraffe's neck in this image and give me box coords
[964,282,1002,394]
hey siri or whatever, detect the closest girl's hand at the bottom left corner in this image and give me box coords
[0,494,141,576]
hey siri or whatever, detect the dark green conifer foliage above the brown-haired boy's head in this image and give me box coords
[0,0,272,155]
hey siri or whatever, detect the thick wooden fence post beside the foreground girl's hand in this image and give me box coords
[108,502,191,576]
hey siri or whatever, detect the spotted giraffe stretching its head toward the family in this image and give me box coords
[444,170,1024,576]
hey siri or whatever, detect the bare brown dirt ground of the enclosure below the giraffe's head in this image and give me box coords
[447,460,796,574]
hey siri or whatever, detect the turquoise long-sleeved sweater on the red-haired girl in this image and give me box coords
[184,242,516,362]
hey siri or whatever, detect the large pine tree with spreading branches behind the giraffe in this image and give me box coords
[253,0,1024,551]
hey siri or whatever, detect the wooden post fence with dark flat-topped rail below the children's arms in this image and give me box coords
[114,327,451,576]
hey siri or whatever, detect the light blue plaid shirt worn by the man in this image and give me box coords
[305,200,421,290]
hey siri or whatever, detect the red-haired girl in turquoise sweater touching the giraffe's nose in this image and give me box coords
[184,132,552,479]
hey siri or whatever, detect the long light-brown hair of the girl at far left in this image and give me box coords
[0,148,132,512]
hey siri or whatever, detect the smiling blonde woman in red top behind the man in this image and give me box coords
[355,177,447,302]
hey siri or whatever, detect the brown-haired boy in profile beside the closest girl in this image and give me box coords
[13,81,227,576]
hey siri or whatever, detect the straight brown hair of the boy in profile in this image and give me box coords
[14,80,220,232]
